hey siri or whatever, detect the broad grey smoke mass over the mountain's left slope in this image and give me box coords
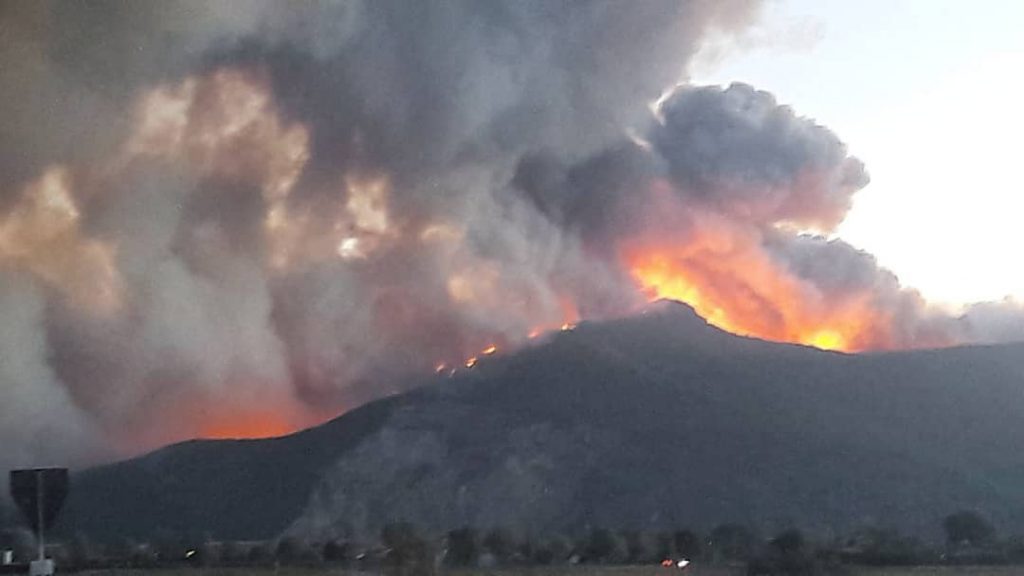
[0,0,756,465]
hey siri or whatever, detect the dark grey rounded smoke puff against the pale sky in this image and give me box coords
[650,84,867,230]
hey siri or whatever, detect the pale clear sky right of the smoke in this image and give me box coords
[692,0,1024,303]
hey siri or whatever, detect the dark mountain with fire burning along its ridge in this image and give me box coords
[54,302,1024,539]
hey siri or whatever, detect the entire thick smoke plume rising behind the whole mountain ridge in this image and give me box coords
[0,0,1022,465]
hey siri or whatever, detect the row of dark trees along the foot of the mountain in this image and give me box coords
[0,510,1024,576]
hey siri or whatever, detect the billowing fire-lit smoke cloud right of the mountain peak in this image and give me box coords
[514,84,1024,351]
